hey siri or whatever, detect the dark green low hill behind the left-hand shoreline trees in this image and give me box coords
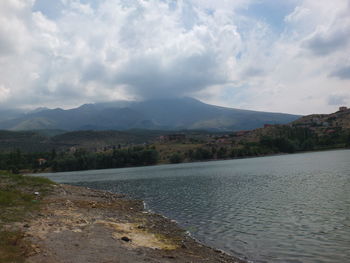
[0,129,206,153]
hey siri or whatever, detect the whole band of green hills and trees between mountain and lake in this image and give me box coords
[0,117,350,173]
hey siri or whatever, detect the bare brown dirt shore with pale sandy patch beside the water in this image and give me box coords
[21,185,244,263]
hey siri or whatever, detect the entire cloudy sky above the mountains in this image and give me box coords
[0,0,350,114]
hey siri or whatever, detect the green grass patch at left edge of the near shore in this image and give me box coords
[0,172,53,263]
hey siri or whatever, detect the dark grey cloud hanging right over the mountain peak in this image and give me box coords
[116,52,225,98]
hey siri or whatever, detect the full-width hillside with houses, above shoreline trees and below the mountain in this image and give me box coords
[0,108,350,156]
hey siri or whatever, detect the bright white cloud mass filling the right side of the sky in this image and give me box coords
[202,1,350,114]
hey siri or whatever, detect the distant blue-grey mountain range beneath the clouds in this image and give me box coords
[0,98,300,131]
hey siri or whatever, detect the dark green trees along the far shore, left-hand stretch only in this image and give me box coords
[0,147,159,173]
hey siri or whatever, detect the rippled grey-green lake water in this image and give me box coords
[36,150,350,263]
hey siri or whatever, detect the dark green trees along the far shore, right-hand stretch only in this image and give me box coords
[169,126,350,163]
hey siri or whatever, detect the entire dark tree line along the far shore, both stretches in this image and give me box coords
[0,126,350,173]
